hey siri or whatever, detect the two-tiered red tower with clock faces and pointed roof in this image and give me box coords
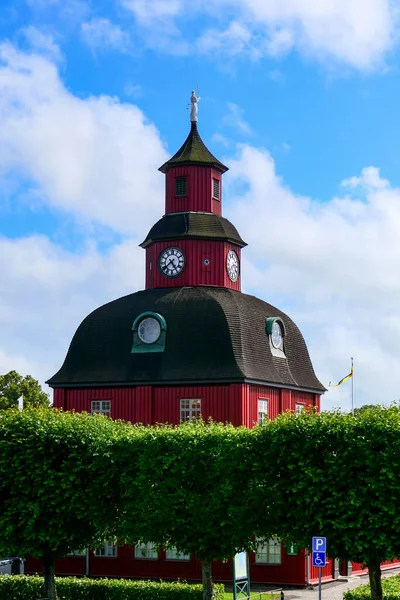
[141,121,246,291]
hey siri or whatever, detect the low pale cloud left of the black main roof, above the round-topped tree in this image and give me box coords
[0,236,144,394]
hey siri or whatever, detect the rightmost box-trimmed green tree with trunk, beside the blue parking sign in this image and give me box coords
[256,406,400,600]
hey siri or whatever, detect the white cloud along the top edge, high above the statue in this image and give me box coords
[122,0,399,71]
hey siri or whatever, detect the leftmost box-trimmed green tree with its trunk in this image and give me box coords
[0,409,124,600]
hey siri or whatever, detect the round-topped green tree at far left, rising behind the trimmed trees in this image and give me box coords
[0,371,50,410]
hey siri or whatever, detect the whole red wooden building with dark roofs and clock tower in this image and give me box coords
[26,110,344,585]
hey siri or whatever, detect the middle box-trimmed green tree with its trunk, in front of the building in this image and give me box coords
[120,421,264,600]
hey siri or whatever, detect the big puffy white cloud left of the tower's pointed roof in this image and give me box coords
[0,44,168,234]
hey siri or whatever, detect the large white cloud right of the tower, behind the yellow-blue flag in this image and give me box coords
[224,146,400,408]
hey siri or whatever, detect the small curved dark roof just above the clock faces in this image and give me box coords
[140,212,247,248]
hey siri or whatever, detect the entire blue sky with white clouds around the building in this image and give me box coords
[0,0,400,408]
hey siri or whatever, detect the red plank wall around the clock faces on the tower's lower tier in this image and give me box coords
[146,239,240,291]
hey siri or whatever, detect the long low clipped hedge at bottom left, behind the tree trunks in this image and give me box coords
[0,575,224,600]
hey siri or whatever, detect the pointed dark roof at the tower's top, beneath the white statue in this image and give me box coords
[159,122,228,173]
